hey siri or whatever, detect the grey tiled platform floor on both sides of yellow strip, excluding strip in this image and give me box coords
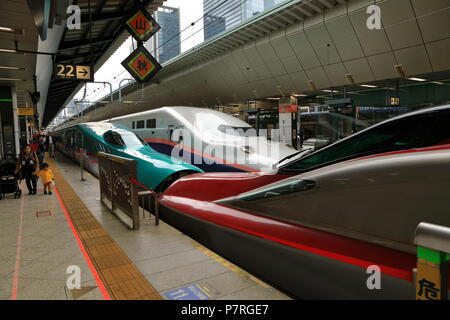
[0,154,289,300]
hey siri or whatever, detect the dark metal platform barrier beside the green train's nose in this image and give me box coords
[98,152,159,230]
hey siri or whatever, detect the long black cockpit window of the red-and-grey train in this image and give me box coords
[281,113,450,170]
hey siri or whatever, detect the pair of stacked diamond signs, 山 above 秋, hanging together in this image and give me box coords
[122,7,162,83]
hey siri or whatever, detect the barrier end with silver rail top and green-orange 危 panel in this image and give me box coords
[414,222,450,300]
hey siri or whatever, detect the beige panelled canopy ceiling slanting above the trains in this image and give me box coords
[79,0,450,120]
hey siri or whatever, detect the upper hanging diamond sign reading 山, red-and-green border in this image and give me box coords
[125,8,161,41]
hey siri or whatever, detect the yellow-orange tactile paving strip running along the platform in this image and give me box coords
[48,159,162,300]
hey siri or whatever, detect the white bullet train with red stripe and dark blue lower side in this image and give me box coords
[109,107,297,172]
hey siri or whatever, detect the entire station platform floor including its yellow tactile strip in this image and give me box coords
[0,153,290,300]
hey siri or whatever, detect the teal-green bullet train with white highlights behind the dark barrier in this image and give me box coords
[54,122,203,192]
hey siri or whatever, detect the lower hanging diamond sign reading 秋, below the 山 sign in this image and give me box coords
[122,47,162,83]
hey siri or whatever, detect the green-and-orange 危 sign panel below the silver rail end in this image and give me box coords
[416,246,449,300]
